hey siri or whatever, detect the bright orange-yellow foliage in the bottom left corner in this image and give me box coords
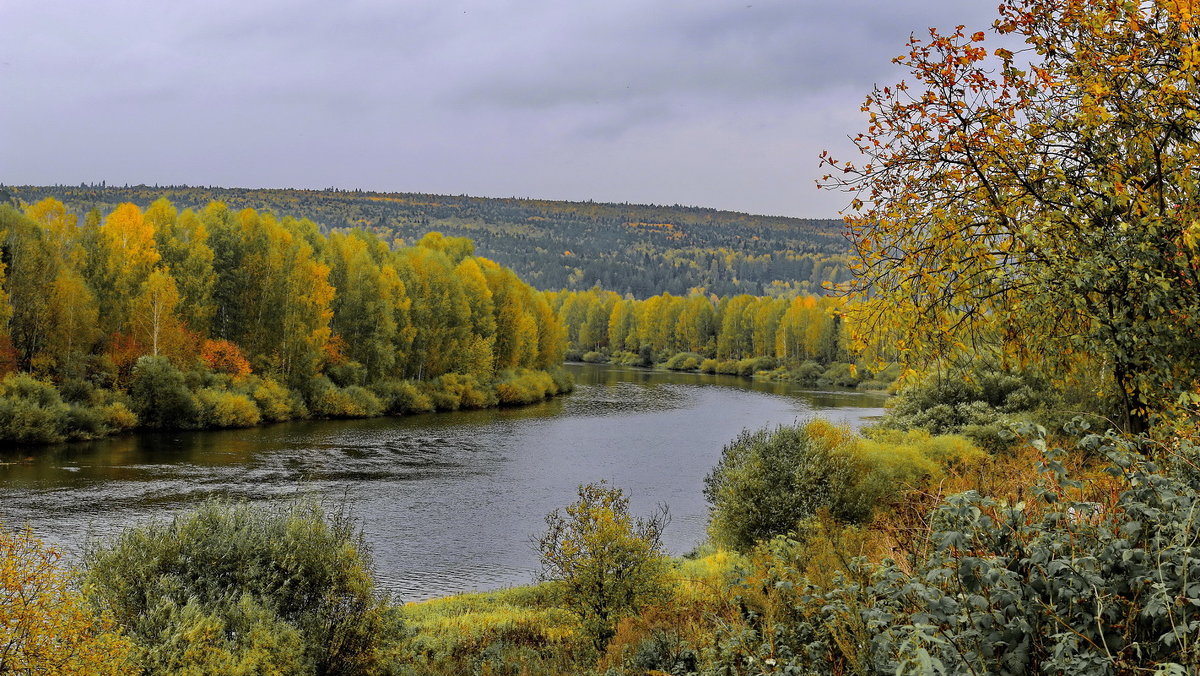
[0,526,131,676]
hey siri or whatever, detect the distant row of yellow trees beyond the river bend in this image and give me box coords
[550,288,900,389]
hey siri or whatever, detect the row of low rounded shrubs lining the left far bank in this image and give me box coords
[0,357,574,443]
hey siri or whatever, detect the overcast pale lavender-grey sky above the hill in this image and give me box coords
[0,0,995,217]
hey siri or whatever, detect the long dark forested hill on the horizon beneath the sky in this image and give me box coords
[9,185,848,298]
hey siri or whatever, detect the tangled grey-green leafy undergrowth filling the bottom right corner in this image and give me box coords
[700,432,1200,674]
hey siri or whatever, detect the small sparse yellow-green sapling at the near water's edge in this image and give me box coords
[535,481,670,650]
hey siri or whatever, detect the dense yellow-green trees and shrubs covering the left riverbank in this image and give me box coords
[0,198,571,443]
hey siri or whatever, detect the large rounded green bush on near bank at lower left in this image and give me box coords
[84,502,388,675]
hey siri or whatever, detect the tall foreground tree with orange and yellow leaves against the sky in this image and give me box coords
[822,0,1200,432]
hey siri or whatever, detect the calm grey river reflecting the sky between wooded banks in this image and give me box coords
[0,365,883,600]
